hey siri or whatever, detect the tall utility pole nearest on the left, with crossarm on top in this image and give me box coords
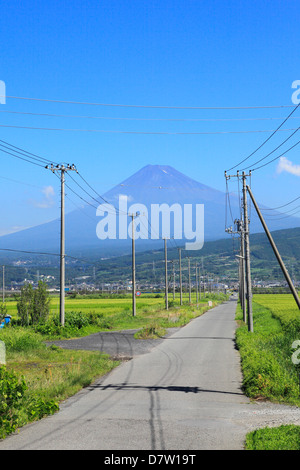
[46,164,77,326]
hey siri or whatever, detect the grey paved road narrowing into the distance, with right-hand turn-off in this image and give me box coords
[0,301,300,451]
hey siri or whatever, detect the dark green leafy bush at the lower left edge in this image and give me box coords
[0,366,27,439]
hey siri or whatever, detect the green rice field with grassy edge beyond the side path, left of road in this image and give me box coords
[2,293,226,338]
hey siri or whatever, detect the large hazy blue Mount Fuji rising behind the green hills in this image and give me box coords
[0,165,300,258]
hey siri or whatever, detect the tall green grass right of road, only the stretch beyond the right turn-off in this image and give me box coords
[236,295,300,404]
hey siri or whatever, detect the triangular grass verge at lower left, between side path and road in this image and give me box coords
[0,328,119,438]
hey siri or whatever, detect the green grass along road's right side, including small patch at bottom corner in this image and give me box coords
[236,294,300,450]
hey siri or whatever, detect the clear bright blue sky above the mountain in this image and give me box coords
[0,0,300,234]
